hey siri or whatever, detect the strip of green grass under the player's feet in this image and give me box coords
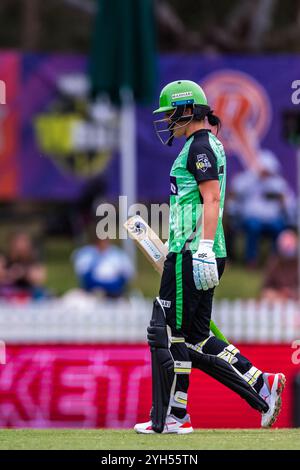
[0,429,300,450]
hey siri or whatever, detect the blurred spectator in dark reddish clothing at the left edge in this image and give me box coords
[0,232,47,299]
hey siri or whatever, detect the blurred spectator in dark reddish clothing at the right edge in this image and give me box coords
[261,230,299,300]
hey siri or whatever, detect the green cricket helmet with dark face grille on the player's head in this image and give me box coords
[153,80,210,145]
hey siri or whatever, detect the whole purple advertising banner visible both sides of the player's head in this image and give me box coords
[0,53,300,202]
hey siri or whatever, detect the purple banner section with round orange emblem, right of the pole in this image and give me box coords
[138,55,300,198]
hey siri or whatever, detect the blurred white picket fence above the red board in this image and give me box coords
[0,294,300,344]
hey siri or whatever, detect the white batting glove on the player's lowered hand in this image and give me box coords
[193,240,219,290]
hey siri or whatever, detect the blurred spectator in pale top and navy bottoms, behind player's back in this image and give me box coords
[227,150,296,266]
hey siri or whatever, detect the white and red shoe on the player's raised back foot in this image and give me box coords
[259,373,286,428]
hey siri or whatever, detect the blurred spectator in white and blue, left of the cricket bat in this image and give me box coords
[72,239,134,298]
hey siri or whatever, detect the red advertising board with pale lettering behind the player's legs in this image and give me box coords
[0,344,300,428]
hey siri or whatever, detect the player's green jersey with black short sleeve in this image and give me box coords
[169,129,226,258]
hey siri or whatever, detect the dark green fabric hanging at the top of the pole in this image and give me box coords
[90,0,156,104]
